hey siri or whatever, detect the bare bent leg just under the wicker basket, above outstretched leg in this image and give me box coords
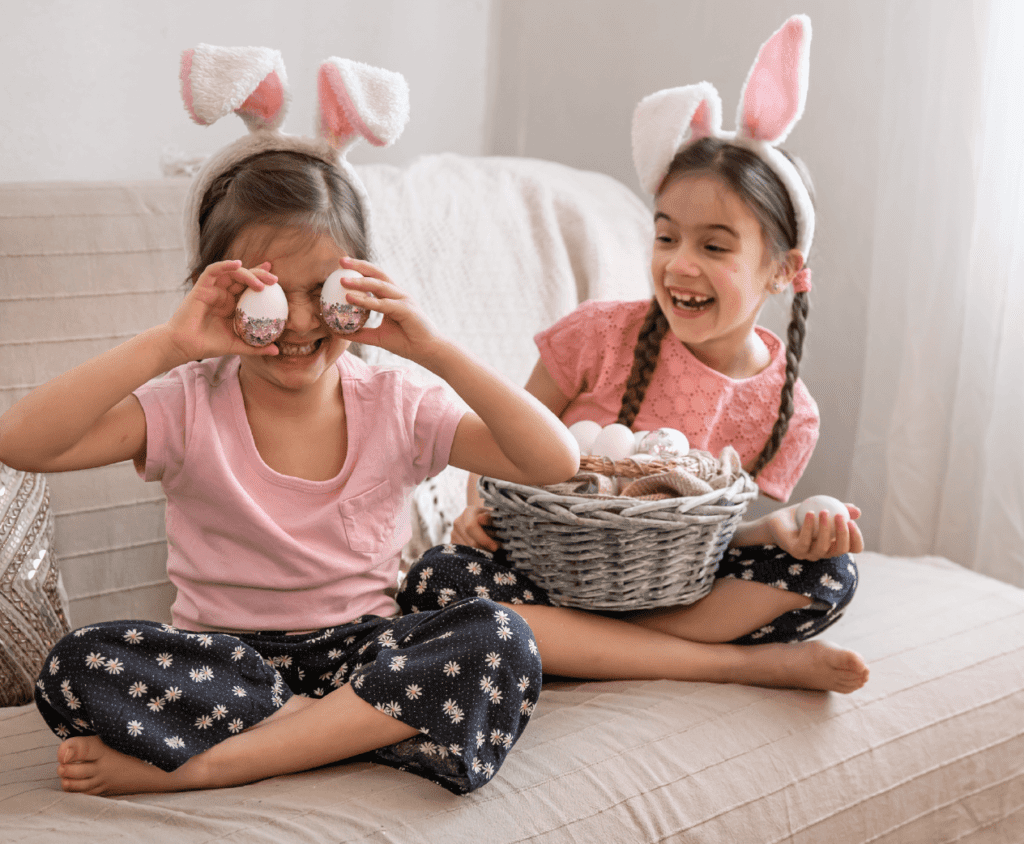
[630,578,811,642]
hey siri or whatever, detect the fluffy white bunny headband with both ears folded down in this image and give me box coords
[181,44,409,265]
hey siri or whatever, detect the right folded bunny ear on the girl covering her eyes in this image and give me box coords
[316,57,409,153]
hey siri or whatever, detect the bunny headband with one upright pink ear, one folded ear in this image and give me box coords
[633,14,814,292]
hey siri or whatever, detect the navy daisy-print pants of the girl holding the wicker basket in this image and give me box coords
[397,545,857,644]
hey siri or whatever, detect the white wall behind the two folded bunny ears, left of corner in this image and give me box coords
[0,0,492,181]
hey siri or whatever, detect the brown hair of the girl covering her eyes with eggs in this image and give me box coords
[189,151,370,284]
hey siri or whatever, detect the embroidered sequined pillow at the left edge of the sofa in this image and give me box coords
[0,464,70,707]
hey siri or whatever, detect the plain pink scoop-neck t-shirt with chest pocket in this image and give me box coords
[135,353,464,631]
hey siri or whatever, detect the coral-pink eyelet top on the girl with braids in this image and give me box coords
[535,300,818,501]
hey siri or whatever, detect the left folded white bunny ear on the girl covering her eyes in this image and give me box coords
[181,44,288,131]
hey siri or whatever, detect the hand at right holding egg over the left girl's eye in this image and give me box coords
[327,257,439,363]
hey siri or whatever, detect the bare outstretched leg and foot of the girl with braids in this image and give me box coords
[509,606,868,692]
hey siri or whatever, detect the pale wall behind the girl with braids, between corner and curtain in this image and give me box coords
[490,0,887,508]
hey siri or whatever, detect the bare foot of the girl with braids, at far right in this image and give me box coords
[737,639,869,694]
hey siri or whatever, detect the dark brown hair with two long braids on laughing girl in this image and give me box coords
[617,137,813,475]
